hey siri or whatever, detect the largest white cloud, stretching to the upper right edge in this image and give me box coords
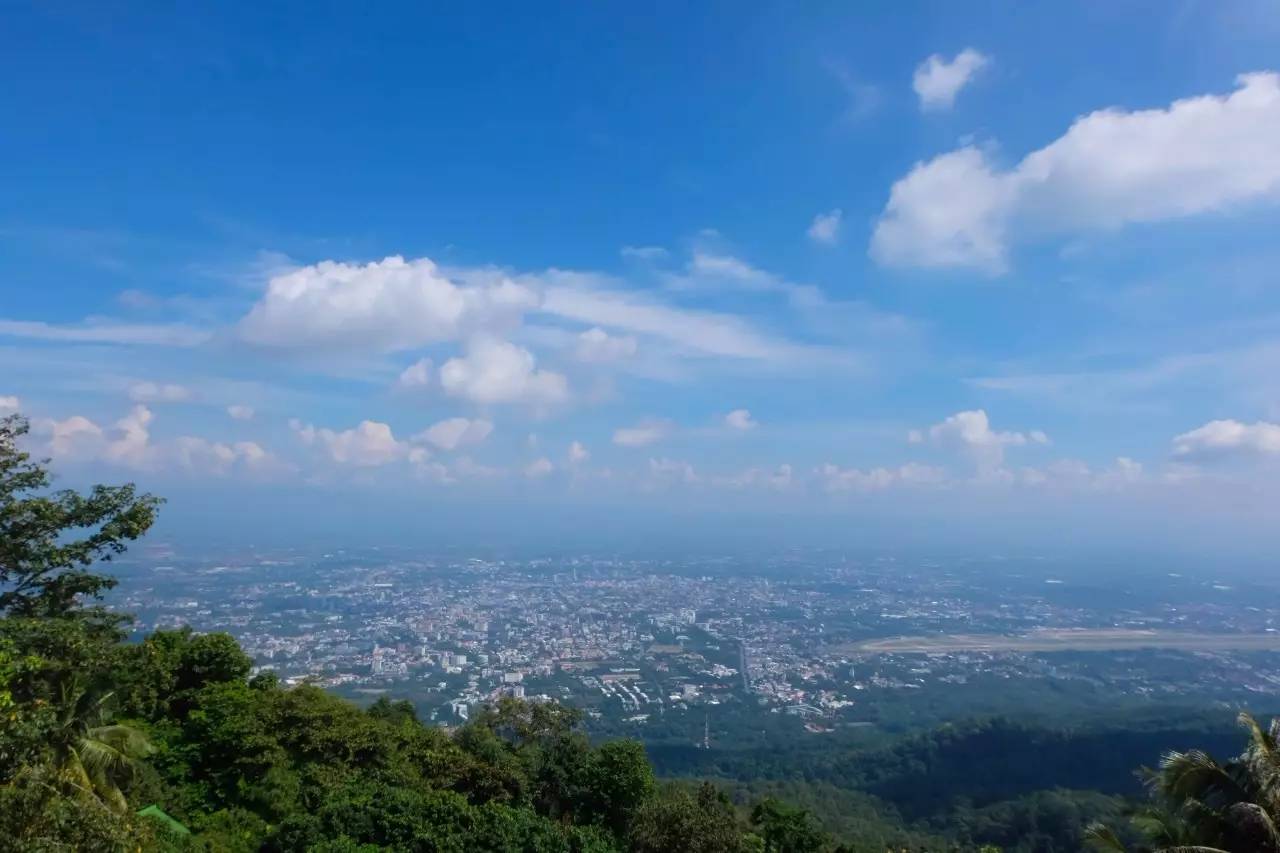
[870,72,1280,273]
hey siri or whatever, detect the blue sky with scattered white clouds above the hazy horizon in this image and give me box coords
[0,1,1280,547]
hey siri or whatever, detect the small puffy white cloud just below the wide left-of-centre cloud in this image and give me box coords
[440,336,568,406]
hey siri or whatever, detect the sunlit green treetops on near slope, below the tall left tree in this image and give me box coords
[0,617,820,853]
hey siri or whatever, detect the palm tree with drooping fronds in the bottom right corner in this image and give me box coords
[1088,713,1280,853]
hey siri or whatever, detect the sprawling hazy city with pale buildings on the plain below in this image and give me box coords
[107,548,1280,742]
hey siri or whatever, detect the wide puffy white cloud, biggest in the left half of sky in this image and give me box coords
[239,256,538,352]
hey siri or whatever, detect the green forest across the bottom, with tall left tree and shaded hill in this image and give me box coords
[0,416,1280,853]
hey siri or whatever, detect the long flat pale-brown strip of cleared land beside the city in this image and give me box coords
[831,629,1280,654]
